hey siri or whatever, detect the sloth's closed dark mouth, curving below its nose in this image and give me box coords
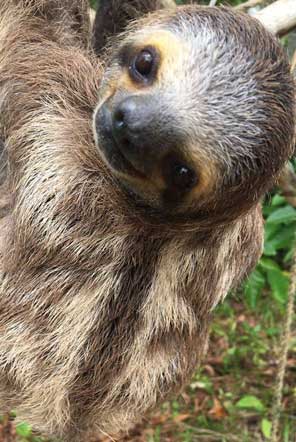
[95,104,147,179]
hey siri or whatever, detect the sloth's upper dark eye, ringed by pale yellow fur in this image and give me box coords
[129,48,156,83]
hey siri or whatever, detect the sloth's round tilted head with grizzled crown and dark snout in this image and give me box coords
[94,6,294,221]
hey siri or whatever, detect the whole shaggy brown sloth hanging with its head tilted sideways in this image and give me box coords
[0,0,295,441]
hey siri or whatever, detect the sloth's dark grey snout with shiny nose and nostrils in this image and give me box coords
[95,95,162,176]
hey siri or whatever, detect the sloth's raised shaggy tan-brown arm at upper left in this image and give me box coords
[0,0,100,224]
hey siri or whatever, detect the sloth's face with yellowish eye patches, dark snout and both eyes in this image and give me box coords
[95,31,209,210]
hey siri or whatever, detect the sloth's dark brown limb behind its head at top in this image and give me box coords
[93,0,176,55]
